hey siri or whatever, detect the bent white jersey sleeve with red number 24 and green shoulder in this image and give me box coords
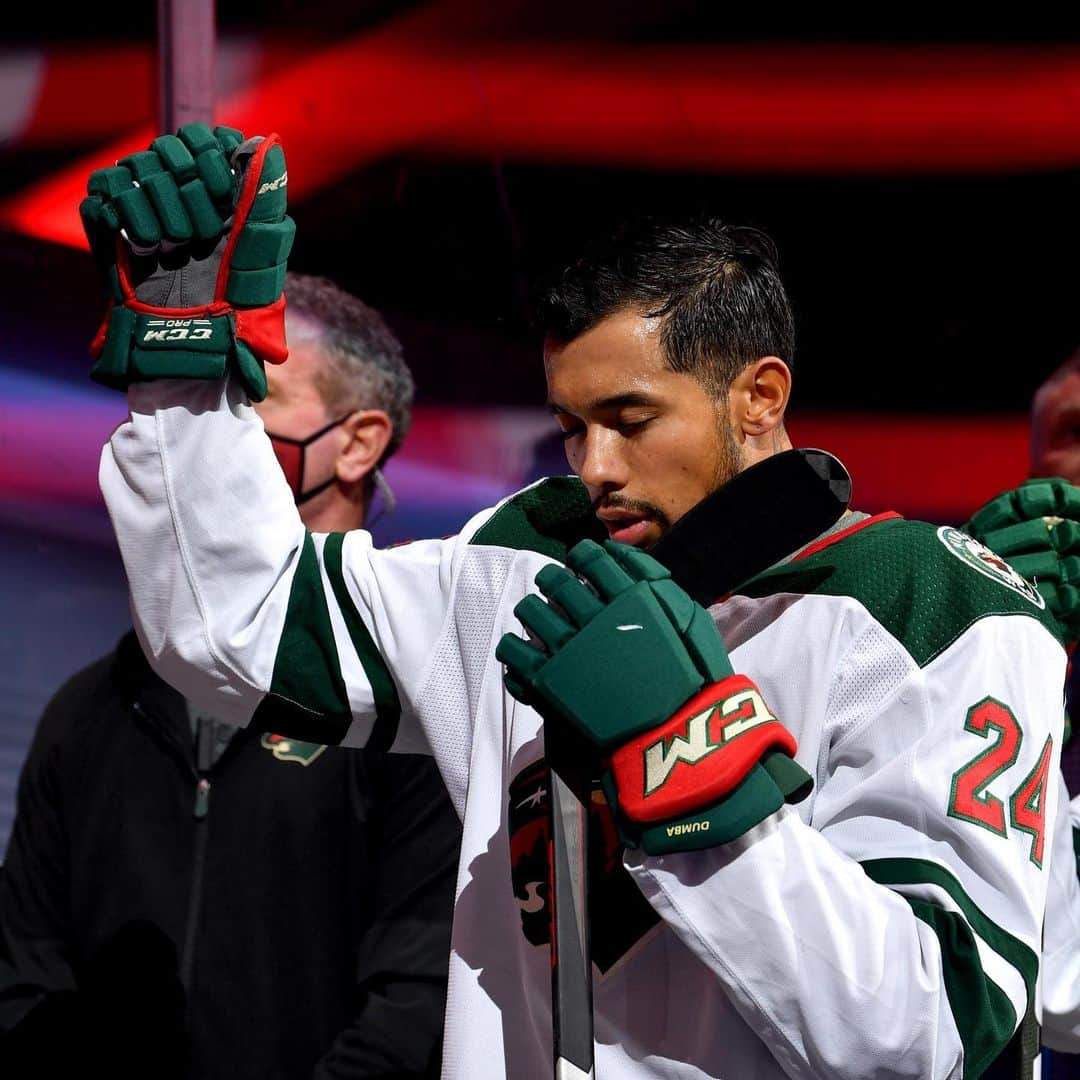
[627,522,1065,1080]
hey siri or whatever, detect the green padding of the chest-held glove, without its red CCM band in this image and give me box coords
[496,540,810,854]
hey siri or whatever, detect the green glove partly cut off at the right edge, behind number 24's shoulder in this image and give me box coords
[963,478,1080,642]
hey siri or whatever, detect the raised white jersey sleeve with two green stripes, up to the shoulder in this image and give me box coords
[100,380,583,809]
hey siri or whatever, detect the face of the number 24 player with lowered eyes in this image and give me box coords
[544,311,742,548]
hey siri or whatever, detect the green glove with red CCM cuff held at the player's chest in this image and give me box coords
[496,540,812,854]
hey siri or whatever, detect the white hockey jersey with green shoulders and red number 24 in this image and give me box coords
[100,381,1065,1080]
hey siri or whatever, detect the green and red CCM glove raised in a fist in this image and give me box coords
[79,124,296,401]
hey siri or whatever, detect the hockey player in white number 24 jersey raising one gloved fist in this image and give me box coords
[84,129,1065,1080]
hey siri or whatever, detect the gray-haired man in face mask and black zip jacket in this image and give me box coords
[0,274,460,1080]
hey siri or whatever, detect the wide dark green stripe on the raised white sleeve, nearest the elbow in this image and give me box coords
[252,532,352,743]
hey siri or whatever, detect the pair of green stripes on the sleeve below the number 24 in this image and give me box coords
[862,859,1039,1080]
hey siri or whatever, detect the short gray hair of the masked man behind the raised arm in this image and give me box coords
[285,272,415,465]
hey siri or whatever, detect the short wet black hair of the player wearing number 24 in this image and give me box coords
[535,216,795,392]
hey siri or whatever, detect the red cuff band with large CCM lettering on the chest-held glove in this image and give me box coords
[611,675,797,822]
